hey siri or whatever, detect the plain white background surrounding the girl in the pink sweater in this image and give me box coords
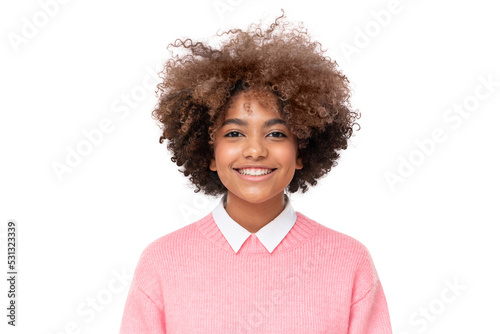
[0,0,500,334]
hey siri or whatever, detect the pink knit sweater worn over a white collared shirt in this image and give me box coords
[120,207,392,334]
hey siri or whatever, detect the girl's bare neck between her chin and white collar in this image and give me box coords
[224,193,285,233]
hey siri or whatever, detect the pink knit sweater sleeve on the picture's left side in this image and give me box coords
[120,241,166,334]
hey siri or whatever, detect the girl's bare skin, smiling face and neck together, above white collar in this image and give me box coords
[210,91,302,233]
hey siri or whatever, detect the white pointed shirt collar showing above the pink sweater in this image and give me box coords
[212,194,297,253]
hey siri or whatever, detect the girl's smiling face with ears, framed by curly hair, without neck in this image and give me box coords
[210,93,302,203]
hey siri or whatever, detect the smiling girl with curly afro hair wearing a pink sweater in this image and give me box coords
[120,13,391,334]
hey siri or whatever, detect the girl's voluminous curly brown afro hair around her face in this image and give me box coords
[152,10,361,196]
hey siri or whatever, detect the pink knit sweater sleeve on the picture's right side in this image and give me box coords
[348,244,392,334]
